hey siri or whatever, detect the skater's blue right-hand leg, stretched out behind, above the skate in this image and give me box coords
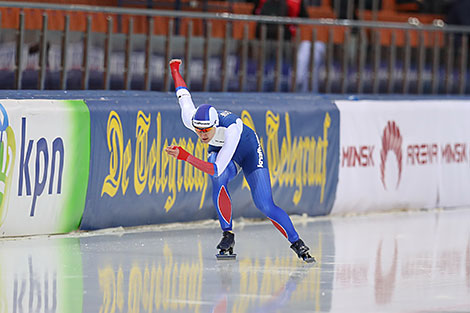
[246,168,299,243]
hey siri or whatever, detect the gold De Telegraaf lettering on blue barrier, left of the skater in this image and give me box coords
[101,111,208,212]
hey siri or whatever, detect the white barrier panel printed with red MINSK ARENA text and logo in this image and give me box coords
[332,100,470,213]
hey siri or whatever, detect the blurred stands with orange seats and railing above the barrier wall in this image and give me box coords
[0,0,470,95]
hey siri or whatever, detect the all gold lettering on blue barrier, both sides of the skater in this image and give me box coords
[101,111,331,212]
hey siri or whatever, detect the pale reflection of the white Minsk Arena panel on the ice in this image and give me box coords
[332,210,470,312]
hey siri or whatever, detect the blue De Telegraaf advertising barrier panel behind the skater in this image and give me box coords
[81,93,339,229]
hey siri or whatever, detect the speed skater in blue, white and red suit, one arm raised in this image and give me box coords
[165,59,315,263]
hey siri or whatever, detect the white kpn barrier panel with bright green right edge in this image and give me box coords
[0,98,90,236]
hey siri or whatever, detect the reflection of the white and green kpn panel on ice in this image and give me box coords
[0,238,83,313]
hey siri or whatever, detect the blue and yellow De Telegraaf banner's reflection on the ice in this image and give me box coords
[81,223,332,312]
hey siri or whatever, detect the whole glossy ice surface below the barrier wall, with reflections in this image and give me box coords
[0,209,470,313]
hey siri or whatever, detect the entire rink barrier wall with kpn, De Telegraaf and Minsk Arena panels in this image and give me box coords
[0,91,470,236]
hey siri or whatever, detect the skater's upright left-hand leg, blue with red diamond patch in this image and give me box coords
[208,153,237,231]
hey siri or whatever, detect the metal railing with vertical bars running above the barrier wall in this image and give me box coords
[0,1,470,94]
